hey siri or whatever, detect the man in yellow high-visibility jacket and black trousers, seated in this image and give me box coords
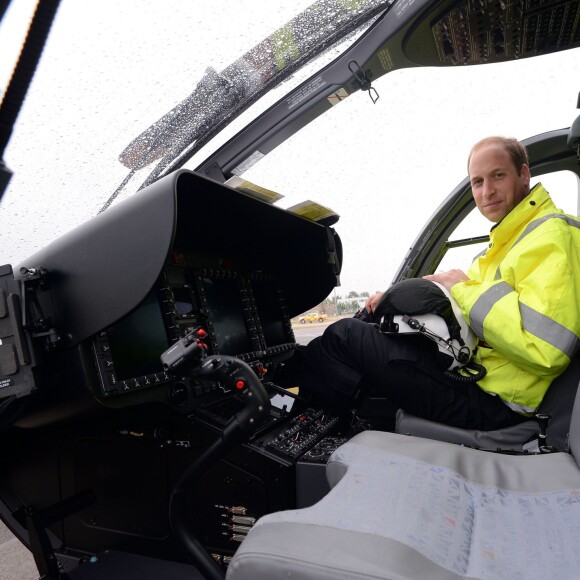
[295,137,580,430]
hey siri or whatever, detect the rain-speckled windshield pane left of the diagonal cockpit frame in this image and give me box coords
[0,0,390,260]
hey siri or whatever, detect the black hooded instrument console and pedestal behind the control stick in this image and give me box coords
[0,170,352,560]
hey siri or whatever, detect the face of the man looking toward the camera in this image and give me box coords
[469,143,530,223]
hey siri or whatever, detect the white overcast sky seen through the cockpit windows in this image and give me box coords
[0,0,580,294]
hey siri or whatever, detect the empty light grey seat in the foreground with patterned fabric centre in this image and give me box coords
[228,431,580,580]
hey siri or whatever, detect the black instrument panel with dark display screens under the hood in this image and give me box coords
[92,252,295,399]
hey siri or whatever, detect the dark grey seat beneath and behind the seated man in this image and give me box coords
[395,353,580,451]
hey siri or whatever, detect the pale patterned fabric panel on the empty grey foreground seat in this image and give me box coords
[263,444,580,580]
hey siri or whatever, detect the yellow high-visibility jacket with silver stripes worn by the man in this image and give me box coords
[451,184,580,413]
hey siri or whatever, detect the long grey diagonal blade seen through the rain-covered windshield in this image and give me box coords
[101,0,394,211]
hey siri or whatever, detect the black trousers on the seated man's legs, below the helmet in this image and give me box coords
[302,318,526,431]
